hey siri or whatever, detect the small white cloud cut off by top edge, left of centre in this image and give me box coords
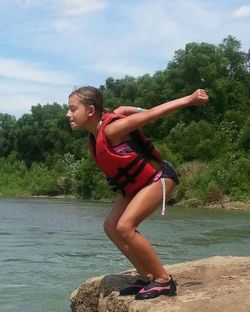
[55,0,107,16]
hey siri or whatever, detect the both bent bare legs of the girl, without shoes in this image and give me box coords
[104,179,175,281]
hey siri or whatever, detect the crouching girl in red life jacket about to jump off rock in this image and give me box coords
[67,87,208,300]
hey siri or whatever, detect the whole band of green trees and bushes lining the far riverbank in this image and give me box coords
[0,36,250,204]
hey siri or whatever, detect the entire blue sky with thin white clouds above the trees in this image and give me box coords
[0,0,250,118]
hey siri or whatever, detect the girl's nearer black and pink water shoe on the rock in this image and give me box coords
[135,275,176,300]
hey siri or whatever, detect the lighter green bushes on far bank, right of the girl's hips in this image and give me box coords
[177,152,250,205]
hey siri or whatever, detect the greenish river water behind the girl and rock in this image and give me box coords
[0,198,250,312]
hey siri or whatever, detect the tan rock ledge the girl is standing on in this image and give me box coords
[70,256,250,312]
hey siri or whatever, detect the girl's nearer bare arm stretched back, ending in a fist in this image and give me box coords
[105,89,208,142]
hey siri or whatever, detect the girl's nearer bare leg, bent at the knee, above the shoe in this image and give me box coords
[116,179,175,281]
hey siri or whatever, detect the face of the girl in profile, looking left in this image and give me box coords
[67,95,91,130]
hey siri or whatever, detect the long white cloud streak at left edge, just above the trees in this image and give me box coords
[0,57,74,85]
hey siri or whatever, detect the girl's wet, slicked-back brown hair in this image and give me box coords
[69,86,104,115]
